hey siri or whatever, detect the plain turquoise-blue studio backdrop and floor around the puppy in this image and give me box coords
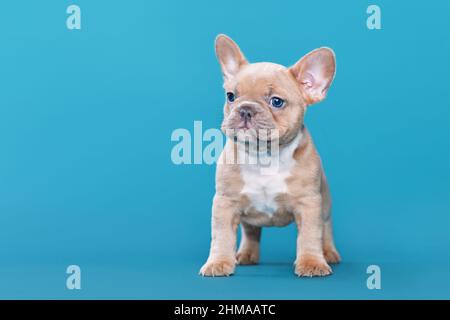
[0,0,450,299]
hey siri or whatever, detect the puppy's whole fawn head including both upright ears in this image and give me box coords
[216,35,335,144]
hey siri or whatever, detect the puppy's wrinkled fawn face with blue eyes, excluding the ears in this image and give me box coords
[222,63,306,142]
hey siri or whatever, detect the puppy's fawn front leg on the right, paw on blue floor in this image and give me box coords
[295,197,332,277]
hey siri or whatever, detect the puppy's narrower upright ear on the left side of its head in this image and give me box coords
[216,34,248,80]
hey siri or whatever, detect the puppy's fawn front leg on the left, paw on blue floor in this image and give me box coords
[200,195,239,277]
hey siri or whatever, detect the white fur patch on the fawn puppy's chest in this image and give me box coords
[241,133,302,215]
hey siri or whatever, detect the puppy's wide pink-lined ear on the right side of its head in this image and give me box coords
[290,48,336,104]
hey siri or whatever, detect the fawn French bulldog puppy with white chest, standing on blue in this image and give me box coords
[200,35,340,277]
